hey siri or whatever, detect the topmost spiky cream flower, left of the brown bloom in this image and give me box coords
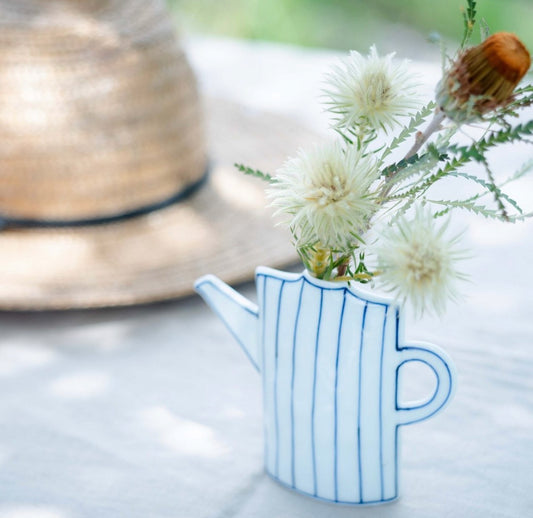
[324,46,419,131]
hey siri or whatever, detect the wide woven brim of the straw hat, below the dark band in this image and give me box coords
[0,100,316,310]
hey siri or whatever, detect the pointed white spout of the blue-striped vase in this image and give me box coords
[194,275,259,370]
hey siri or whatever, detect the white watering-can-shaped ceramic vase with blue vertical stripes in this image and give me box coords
[195,267,456,505]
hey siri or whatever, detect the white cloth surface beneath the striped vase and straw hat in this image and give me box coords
[0,40,533,518]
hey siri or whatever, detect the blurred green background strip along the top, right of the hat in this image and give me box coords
[167,0,533,50]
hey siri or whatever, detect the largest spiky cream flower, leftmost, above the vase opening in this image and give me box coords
[267,142,379,250]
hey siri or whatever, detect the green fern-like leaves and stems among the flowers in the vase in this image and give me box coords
[235,0,533,290]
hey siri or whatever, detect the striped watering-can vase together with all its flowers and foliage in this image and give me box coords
[196,0,533,505]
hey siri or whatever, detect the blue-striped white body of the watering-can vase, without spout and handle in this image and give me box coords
[258,275,396,503]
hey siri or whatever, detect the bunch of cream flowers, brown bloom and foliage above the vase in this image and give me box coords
[236,1,533,314]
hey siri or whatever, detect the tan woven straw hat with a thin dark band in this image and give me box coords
[0,0,316,309]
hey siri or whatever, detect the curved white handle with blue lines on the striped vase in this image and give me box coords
[396,342,457,425]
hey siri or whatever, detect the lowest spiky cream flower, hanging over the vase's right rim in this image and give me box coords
[376,209,466,315]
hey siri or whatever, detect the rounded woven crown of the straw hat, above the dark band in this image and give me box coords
[0,0,206,222]
